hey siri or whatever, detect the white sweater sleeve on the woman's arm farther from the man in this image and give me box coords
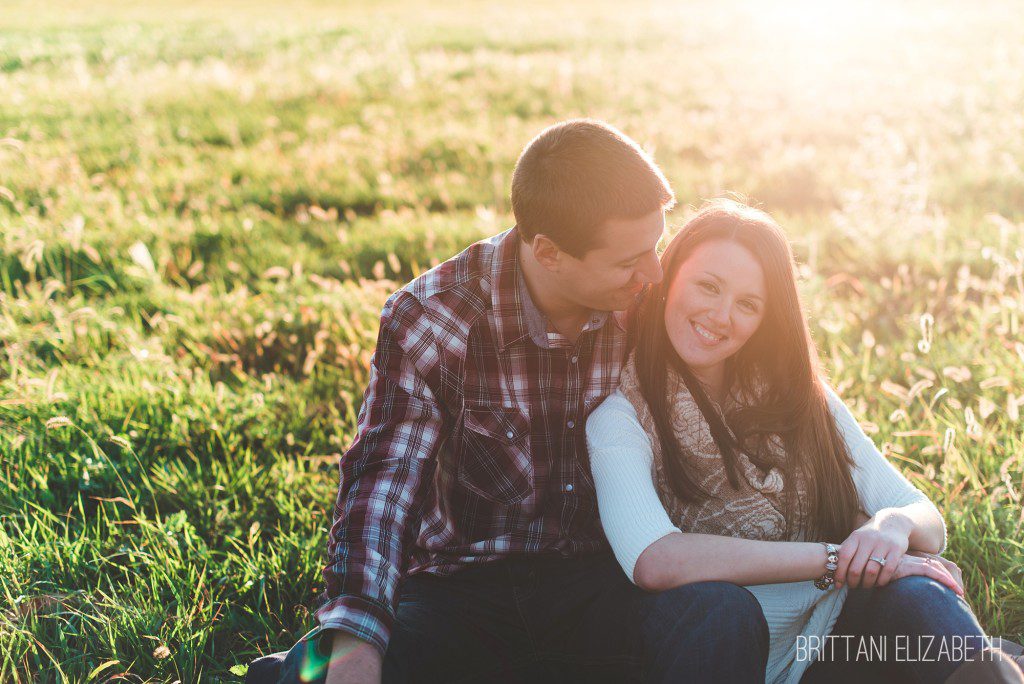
[823,383,946,553]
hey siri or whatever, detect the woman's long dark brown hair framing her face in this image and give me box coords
[631,200,860,543]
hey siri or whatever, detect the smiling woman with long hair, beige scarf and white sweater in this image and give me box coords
[587,201,1019,682]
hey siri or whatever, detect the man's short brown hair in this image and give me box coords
[512,119,676,258]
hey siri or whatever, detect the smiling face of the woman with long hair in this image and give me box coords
[665,240,767,386]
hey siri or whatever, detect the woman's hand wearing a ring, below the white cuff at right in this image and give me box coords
[836,509,910,588]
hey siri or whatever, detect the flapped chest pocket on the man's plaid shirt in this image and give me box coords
[457,404,535,504]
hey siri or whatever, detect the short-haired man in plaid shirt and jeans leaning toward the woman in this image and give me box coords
[249,120,768,683]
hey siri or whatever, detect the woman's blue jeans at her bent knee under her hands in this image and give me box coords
[800,576,987,684]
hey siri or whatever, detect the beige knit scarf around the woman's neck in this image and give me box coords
[618,354,807,541]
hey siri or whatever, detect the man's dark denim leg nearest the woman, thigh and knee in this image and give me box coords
[473,554,768,684]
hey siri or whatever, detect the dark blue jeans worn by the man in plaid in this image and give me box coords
[246,554,768,684]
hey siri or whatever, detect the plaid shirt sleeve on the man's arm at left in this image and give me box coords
[316,291,442,655]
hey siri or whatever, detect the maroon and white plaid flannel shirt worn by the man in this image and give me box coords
[316,228,626,653]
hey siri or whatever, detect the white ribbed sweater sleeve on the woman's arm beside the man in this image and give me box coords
[587,390,679,584]
